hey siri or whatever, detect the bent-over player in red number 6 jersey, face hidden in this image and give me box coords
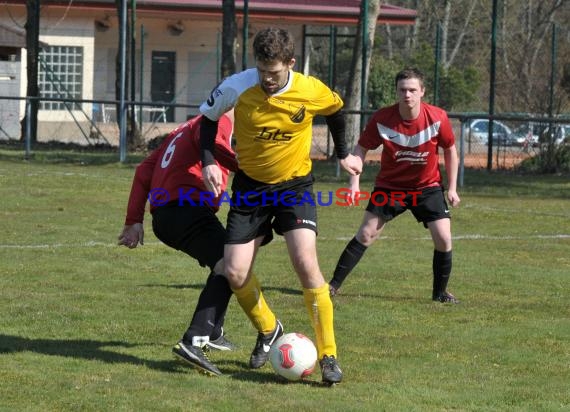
[119,112,237,375]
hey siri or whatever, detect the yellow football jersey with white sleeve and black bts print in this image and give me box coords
[200,69,343,184]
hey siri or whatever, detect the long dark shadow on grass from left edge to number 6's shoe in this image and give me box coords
[0,334,181,372]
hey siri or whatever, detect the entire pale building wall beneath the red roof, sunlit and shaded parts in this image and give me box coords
[0,5,302,142]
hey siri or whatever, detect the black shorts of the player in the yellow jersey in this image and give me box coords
[226,171,317,245]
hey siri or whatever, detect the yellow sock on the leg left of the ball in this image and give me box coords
[232,274,277,334]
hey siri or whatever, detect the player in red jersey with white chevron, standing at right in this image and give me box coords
[329,68,460,303]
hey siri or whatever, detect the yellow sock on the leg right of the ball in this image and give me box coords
[303,283,337,359]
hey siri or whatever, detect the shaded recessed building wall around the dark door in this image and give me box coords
[93,17,302,122]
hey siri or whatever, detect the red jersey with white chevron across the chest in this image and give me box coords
[358,103,455,190]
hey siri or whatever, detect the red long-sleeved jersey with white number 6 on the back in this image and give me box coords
[125,116,237,225]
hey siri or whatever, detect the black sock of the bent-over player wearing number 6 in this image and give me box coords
[182,273,233,344]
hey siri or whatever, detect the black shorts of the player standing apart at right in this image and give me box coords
[366,186,451,228]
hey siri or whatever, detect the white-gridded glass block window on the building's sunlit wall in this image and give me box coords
[39,46,83,110]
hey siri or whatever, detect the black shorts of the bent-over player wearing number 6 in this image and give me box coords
[152,200,226,270]
